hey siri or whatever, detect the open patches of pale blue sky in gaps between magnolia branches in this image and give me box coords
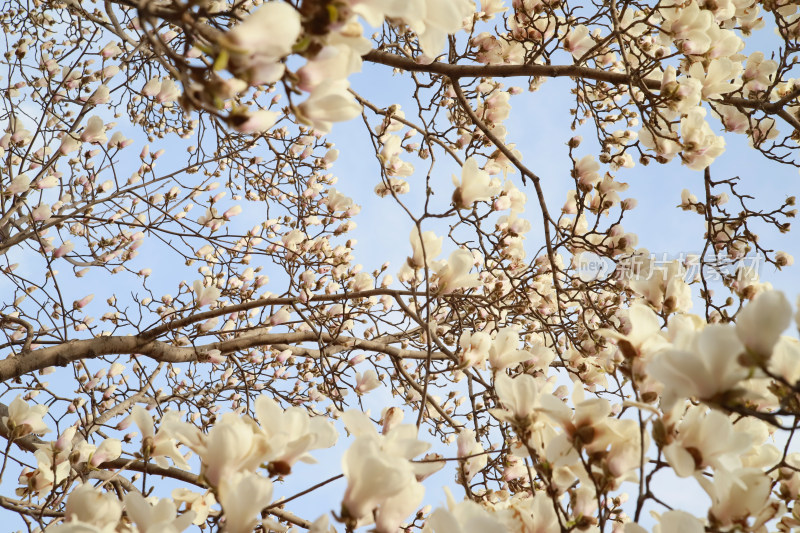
[0,6,800,519]
